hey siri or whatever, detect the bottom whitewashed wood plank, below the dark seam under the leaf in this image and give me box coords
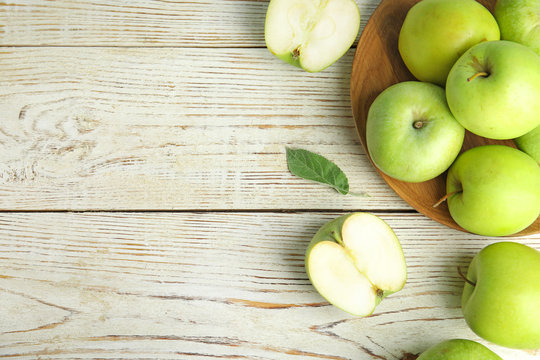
[0,213,540,360]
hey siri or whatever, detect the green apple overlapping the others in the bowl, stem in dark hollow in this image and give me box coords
[446,40,540,139]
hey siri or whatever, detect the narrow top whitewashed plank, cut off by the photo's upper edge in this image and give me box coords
[0,0,379,47]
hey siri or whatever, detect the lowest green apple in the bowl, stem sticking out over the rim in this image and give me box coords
[446,145,540,236]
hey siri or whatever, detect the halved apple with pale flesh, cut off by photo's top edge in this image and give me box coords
[264,0,360,72]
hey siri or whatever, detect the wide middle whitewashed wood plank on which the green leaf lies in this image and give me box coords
[0,48,409,210]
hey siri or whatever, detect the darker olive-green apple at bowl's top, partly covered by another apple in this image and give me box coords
[398,0,500,86]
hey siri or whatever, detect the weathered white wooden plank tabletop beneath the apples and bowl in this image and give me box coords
[0,0,540,360]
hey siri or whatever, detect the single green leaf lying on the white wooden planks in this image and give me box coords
[287,148,349,195]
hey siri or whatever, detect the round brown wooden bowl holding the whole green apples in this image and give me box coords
[351,0,540,236]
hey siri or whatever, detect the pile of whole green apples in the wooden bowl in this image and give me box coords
[366,0,540,236]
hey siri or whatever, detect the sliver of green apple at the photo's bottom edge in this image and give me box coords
[417,339,502,360]
